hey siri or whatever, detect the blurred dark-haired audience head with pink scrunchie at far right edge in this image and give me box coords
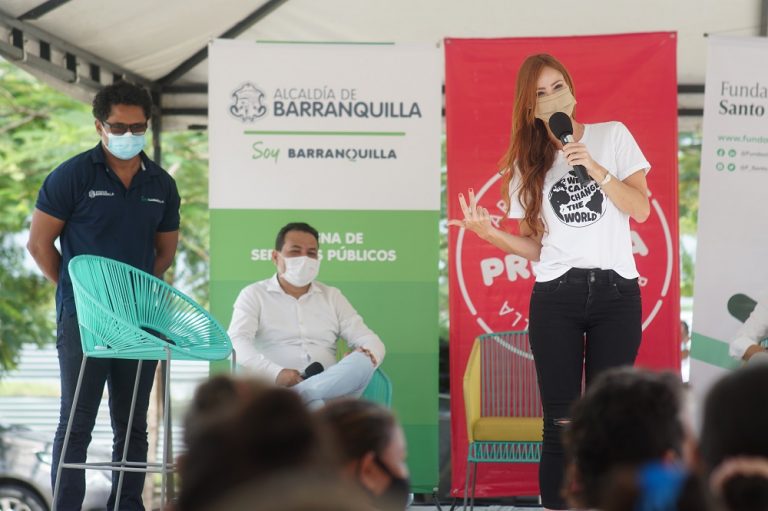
[700,364,768,511]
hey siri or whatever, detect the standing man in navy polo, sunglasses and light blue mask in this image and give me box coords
[27,82,180,510]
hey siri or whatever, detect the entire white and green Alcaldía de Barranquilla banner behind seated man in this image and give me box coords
[209,40,442,492]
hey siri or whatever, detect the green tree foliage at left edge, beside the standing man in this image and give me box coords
[0,61,95,371]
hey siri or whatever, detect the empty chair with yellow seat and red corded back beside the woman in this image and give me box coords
[463,331,544,509]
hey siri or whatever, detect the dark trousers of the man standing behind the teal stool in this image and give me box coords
[51,310,157,511]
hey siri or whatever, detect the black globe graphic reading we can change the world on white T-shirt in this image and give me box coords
[548,170,606,227]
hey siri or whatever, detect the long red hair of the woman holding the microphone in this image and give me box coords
[500,53,575,235]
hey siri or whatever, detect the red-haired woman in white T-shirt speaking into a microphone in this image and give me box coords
[449,54,650,509]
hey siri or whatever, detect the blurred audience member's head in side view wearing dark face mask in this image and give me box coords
[317,399,410,510]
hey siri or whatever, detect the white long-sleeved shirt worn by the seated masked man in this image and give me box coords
[228,275,385,381]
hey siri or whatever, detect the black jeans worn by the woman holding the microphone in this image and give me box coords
[529,268,642,509]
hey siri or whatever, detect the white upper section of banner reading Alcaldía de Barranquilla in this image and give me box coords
[208,40,442,210]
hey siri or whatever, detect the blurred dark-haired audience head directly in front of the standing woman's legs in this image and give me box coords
[565,367,686,508]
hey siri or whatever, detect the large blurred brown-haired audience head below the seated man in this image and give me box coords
[178,375,336,511]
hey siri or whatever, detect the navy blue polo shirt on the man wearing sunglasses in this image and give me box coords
[36,143,180,317]
